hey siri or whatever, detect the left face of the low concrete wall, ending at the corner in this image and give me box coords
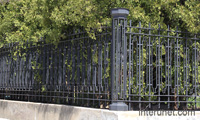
[0,100,117,120]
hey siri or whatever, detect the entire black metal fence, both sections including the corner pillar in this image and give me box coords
[0,9,200,110]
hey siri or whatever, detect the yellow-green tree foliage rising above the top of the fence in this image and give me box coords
[0,0,200,46]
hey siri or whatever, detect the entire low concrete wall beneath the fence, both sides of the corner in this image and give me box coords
[0,100,200,120]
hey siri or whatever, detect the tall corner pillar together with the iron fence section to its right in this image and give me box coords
[111,9,200,110]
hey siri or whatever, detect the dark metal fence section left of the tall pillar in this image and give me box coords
[0,27,111,108]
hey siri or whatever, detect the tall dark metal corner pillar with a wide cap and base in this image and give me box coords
[109,8,129,111]
